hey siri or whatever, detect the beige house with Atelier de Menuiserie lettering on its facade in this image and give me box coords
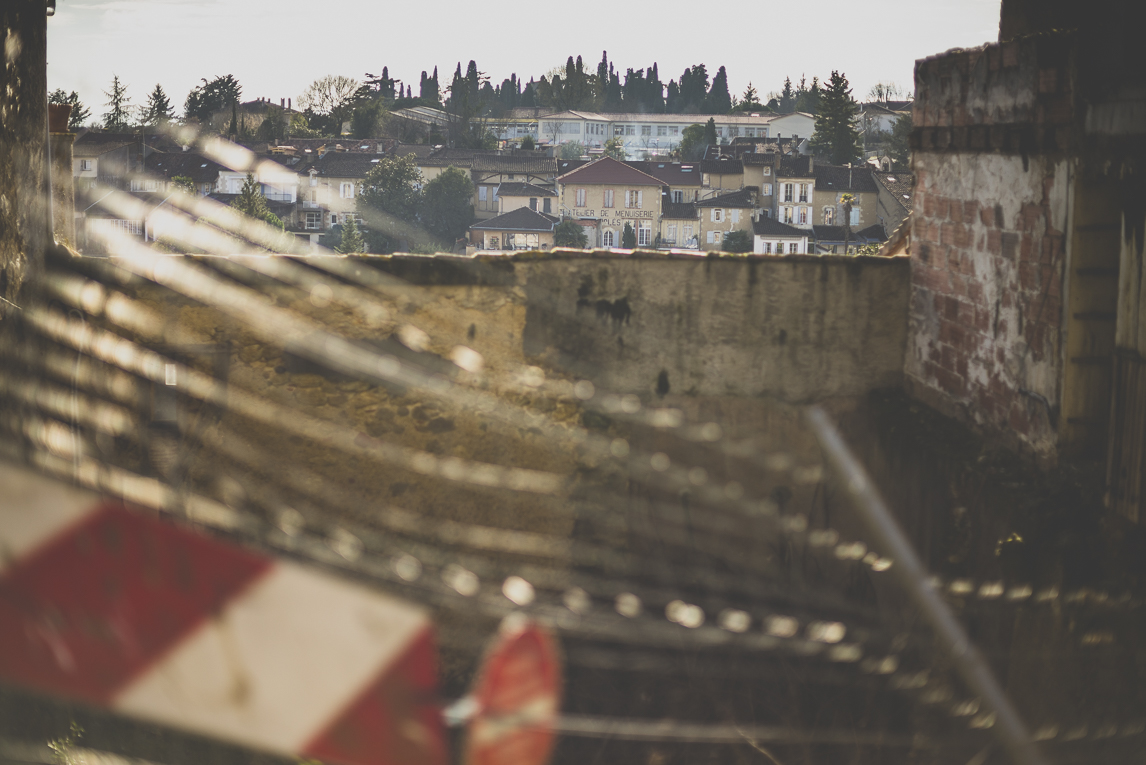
[557,157,662,247]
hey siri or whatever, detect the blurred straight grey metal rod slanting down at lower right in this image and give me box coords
[806,407,1046,765]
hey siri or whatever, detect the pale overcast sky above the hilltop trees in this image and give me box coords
[48,0,999,117]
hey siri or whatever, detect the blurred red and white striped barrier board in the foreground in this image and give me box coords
[0,464,447,765]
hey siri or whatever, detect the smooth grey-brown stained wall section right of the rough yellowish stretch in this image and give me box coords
[515,257,910,402]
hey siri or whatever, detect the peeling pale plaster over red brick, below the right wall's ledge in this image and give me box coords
[905,152,1070,455]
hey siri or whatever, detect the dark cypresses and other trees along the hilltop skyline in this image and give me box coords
[50,52,912,142]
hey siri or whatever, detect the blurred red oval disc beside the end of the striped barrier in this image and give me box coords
[465,617,562,765]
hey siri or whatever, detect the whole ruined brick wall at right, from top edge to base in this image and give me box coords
[904,32,1074,457]
